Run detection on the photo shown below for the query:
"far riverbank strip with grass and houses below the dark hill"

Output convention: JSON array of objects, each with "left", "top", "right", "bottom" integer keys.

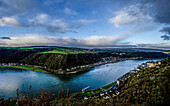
[{"left": 0, "top": 57, "right": 129, "bottom": 75}]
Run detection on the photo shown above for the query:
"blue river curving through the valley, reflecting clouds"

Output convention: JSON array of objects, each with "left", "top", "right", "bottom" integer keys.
[{"left": 0, "top": 59, "right": 162, "bottom": 98}]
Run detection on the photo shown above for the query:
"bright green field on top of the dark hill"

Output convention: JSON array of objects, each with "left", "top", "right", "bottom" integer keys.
[{"left": 40, "top": 49, "right": 85, "bottom": 54}]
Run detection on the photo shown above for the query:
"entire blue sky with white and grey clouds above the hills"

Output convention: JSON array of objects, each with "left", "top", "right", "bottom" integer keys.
[{"left": 0, "top": 0, "right": 170, "bottom": 49}]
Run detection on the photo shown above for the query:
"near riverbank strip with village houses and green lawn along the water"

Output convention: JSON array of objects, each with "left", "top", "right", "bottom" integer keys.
[{"left": 74, "top": 58, "right": 161, "bottom": 99}]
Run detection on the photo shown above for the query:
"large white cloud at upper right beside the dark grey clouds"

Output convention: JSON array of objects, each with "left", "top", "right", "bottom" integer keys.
[{"left": 108, "top": 4, "right": 162, "bottom": 44}]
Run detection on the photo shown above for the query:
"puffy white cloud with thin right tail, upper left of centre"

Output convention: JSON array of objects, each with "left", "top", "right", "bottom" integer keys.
[{"left": 29, "top": 14, "right": 96, "bottom": 33}]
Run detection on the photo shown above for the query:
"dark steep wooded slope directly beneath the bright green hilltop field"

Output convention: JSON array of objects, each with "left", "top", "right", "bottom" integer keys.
[{"left": 22, "top": 53, "right": 101, "bottom": 69}]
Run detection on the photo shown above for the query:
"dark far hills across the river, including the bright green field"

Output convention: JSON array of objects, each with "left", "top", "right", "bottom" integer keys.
[{"left": 0, "top": 47, "right": 168, "bottom": 69}]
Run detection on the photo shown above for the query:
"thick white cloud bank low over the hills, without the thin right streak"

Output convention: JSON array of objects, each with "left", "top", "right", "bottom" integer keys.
[{"left": 0, "top": 34, "right": 123, "bottom": 46}]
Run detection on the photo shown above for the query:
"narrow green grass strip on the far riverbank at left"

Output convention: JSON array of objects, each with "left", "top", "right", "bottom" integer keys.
[{"left": 0, "top": 66, "right": 49, "bottom": 73}]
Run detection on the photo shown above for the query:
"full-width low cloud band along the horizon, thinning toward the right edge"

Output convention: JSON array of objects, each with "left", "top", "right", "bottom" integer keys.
[{"left": 0, "top": 34, "right": 170, "bottom": 49}]
